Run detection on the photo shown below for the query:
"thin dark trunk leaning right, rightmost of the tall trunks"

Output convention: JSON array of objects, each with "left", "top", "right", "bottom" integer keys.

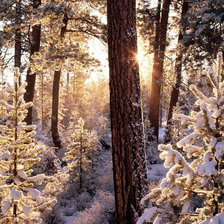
[{"left": 167, "top": 0, "right": 189, "bottom": 124}]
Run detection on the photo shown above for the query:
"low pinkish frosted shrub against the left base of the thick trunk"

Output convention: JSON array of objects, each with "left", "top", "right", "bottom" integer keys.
[{"left": 75, "top": 191, "right": 115, "bottom": 224}]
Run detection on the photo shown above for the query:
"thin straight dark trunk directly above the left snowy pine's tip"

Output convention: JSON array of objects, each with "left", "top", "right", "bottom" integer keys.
[{"left": 14, "top": 0, "right": 22, "bottom": 84}]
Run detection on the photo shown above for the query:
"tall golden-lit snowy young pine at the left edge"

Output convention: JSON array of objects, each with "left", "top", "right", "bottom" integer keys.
[{"left": 0, "top": 69, "right": 51, "bottom": 224}]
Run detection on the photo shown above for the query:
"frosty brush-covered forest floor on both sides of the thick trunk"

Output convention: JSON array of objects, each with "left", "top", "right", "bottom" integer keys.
[{"left": 36, "top": 125, "right": 167, "bottom": 224}]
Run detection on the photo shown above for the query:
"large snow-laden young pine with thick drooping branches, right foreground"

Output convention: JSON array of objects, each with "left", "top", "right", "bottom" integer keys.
[{"left": 138, "top": 53, "right": 224, "bottom": 224}]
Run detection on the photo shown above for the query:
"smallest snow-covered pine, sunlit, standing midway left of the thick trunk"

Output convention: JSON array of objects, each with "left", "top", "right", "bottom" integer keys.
[{"left": 65, "top": 118, "right": 98, "bottom": 191}]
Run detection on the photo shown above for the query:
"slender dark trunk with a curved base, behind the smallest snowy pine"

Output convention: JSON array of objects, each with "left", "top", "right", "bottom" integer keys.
[{"left": 51, "top": 14, "right": 68, "bottom": 148}]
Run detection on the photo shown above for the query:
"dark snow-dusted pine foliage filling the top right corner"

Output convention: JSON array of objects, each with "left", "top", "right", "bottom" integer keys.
[{"left": 184, "top": 0, "right": 224, "bottom": 64}]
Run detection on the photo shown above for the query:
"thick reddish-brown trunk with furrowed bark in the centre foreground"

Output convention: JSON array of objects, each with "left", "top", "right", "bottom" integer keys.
[{"left": 107, "top": 0, "right": 147, "bottom": 224}]
